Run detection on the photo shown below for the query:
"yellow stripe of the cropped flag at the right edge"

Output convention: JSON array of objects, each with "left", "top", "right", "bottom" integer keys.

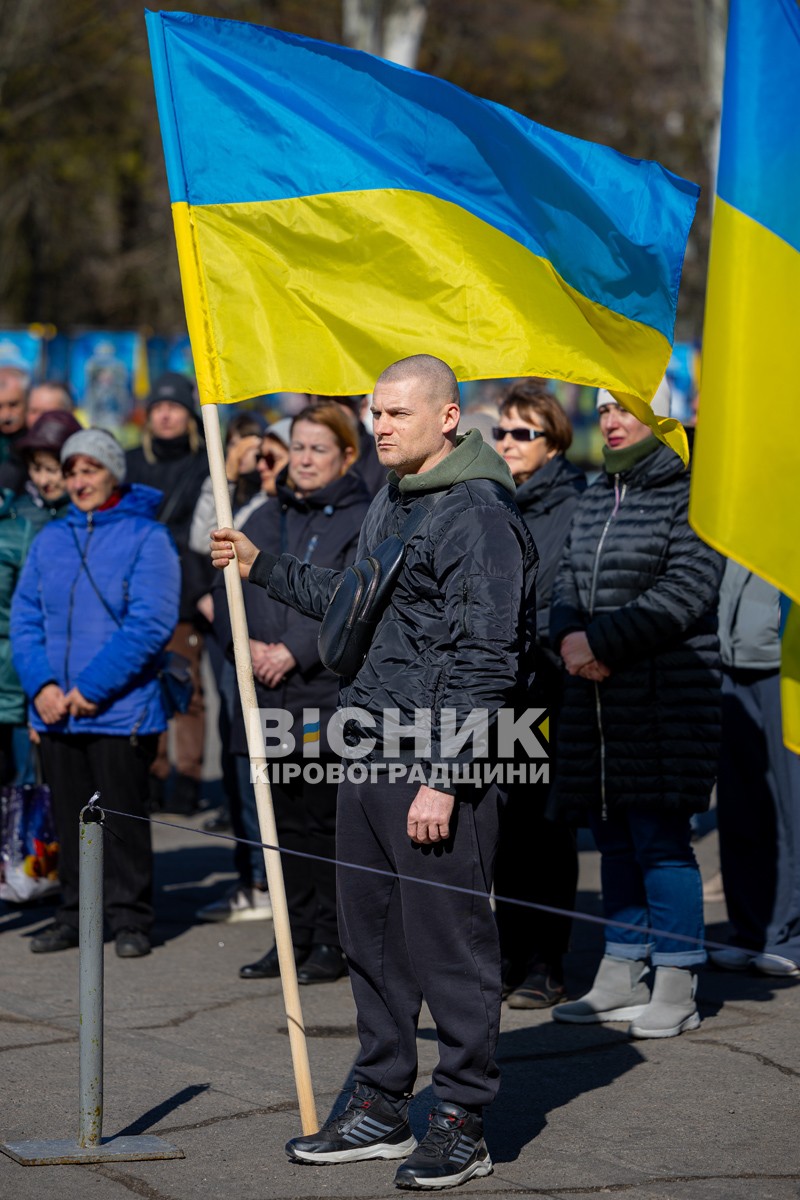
[{"left": 690, "top": 199, "right": 800, "bottom": 601}]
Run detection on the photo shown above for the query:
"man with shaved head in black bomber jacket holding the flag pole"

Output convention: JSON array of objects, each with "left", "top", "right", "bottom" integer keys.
[{"left": 211, "top": 354, "right": 536, "bottom": 1188}]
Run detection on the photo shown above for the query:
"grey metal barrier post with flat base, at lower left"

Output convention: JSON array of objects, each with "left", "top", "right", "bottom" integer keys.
[{"left": 0, "top": 792, "right": 185, "bottom": 1166}]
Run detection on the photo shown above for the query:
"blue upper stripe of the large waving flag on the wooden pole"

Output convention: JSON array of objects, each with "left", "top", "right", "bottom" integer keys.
[{"left": 149, "top": 13, "right": 697, "bottom": 340}]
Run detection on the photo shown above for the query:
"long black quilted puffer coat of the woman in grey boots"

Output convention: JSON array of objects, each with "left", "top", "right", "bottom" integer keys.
[{"left": 551, "top": 446, "right": 723, "bottom": 812}]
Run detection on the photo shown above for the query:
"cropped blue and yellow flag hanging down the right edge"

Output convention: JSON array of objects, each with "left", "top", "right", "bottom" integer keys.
[{"left": 690, "top": 0, "right": 800, "bottom": 750}]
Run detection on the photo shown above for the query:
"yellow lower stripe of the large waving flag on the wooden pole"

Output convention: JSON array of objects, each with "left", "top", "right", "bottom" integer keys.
[{"left": 173, "top": 190, "right": 670, "bottom": 403}]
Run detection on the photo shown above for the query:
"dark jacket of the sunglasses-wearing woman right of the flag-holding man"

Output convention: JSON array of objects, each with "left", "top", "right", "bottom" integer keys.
[{"left": 517, "top": 454, "right": 587, "bottom": 703}]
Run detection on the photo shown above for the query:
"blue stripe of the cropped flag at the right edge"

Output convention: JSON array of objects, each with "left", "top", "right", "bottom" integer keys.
[{"left": 717, "top": 0, "right": 800, "bottom": 251}]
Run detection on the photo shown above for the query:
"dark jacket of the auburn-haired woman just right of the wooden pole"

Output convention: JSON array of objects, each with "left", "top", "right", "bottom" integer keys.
[{"left": 219, "top": 468, "right": 369, "bottom": 755}]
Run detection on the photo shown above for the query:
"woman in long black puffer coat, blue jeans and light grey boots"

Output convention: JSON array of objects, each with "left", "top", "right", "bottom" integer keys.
[{"left": 551, "top": 382, "right": 723, "bottom": 1038}]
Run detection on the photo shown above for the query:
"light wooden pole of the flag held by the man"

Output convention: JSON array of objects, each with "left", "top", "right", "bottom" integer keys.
[{"left": 201, "top": 404, "right": 319, "bottom": 1134}]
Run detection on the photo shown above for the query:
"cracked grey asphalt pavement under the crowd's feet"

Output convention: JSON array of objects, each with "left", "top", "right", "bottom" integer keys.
[{"left": 0, "top": 796, "right": 800, "bottom": 1200}]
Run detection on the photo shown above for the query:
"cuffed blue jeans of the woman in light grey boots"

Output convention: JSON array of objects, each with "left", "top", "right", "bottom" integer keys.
[{"left": 589, "top": 808, "right": 706, "bottom": 967}]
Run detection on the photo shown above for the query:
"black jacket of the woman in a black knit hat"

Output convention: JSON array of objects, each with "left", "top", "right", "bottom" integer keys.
[{"left": 125, "top": 437, "right": 213, "bottom": 622}]
